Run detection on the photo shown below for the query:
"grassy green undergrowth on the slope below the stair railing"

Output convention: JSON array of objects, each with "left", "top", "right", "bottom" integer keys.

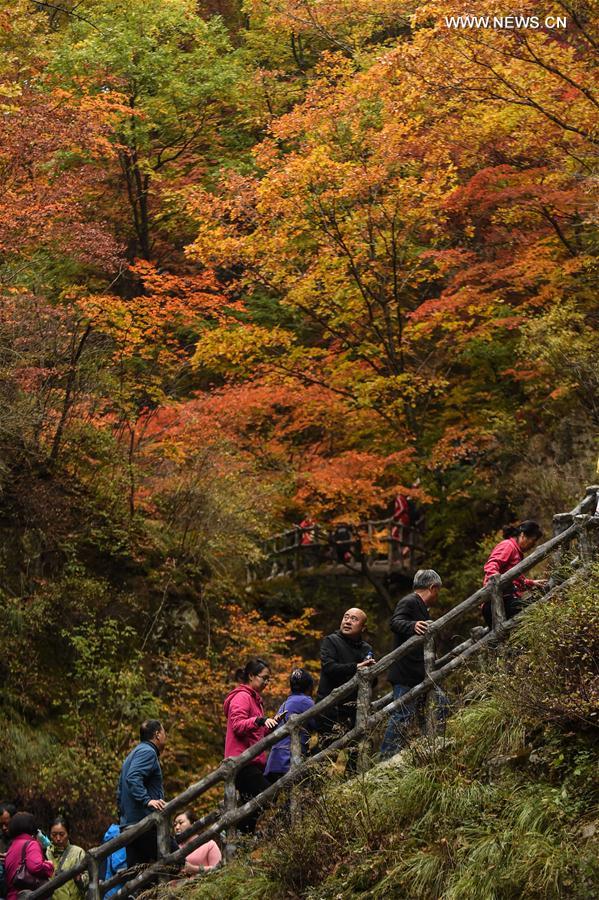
[{"left": 170, "top": 571, "right": 599, "bottom": 900}]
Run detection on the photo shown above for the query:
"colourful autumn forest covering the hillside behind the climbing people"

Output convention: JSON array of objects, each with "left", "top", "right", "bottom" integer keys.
[{"left": 0, "top": 0, "right": 599, "bottom": 843}]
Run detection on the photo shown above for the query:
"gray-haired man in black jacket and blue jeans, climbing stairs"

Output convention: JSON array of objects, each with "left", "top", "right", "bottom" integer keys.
[{"left": 381, "top": 569, "right": 447, "bottom": 756}]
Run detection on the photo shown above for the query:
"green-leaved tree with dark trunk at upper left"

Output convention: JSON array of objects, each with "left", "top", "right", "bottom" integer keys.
[{"left": 50, "top": 0, "right": 240, "bottom": 260}]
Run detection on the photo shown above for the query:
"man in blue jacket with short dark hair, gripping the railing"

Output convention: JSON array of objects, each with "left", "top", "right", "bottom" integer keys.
[{"left": 117, "top": 719, "right": 166, "bottom": 868}]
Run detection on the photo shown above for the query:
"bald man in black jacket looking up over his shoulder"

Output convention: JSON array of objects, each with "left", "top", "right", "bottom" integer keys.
[{"left": 316, "top": 607, "right": 374, "bottom": 735}]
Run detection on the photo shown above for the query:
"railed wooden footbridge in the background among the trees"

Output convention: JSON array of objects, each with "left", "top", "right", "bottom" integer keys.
[{"left": 247, "top": 518, "right": 424, "bottom": 583}]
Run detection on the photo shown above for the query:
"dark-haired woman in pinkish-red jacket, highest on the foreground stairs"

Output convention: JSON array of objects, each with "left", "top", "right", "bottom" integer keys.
[{"left": 482, "top": 519, "right": 546, "bottom": 628}]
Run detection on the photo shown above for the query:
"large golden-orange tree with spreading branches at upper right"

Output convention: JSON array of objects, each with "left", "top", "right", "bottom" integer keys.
[{"left": 189, "top": 3, "right": 595, "bottom": 506}]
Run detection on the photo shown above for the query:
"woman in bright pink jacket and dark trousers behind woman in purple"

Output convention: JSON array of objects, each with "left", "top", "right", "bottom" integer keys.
[{"left": 224, "top": 659, "right": 279, "bottom": 833}]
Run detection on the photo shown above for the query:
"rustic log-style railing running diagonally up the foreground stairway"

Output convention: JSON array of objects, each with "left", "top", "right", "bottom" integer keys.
[{"left": 28, "top": 485, "right": 599, "bottom": 900}]
